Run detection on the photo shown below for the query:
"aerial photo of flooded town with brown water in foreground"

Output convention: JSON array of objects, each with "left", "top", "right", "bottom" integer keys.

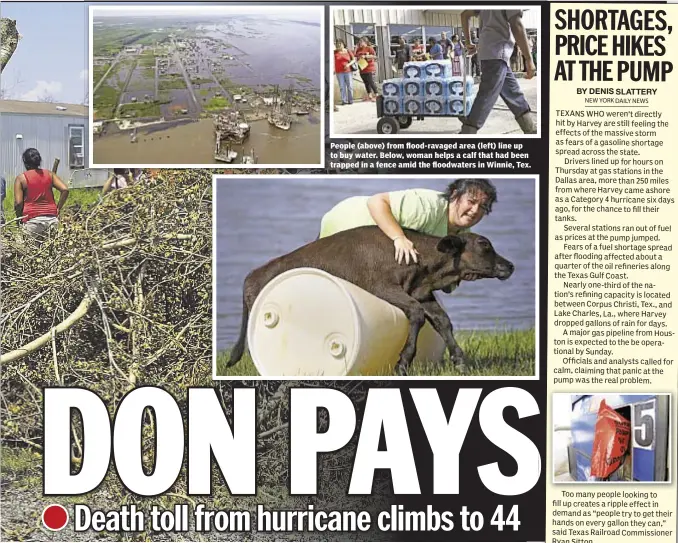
[{"left": 90, "top": 6, "right": 323, "bottom": 166}]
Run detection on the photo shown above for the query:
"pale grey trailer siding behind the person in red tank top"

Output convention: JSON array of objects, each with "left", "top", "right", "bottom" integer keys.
[{"left": 0, "top": 113, "right": 108, "bottom": 187}]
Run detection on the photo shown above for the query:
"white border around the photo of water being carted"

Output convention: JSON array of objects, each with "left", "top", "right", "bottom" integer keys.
[{"left": 327, "top": 4, "right": 548, "bottom": 139}]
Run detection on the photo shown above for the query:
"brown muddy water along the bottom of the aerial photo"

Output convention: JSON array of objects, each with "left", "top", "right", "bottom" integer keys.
[{"left": 94, "top": 116, "right": 320, "bottom": 166}]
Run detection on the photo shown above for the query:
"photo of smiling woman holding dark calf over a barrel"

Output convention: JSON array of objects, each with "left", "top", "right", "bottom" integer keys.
[{"left": 212, "top": 176, "right": 539, "bottom": 379}]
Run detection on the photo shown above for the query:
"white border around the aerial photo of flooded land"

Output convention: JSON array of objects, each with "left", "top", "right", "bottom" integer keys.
[{"left": 87, "top": 2, "right": 326, "bottom": 170}]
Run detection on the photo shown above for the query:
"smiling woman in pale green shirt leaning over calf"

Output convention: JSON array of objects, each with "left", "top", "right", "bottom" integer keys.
[{"left": 319, "top": 179, "right": 497, "bottom": 264}]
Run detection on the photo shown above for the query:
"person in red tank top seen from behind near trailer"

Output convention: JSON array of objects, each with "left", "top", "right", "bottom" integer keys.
[{"left": 14, "top": 148, "right": 68, "bottom": 241}]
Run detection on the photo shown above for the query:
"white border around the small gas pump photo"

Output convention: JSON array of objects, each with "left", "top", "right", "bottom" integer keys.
[{"left": 546, "top": 390, "right": 675, "bottom": 490}]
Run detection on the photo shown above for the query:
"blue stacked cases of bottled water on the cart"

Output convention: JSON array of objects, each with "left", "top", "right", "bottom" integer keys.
[{"left": 382, "top": 60, "right": 475, "bottom": 116}]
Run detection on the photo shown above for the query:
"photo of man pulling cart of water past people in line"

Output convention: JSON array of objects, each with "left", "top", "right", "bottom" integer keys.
[{"left": 330, "top": 6, "right": 541, "bottom": 137}]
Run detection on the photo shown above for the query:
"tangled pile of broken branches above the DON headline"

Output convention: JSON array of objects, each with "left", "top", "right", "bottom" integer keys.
[{"left": 0, "top": 170, "right": 212, "bottom": 450}]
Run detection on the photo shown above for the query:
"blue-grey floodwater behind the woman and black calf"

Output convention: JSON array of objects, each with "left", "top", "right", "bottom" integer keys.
[{"left": 214, "top": 176, "right": 535, "bottom": 350}]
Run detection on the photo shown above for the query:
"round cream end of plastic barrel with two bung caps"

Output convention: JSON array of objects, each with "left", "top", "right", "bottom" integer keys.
[{"left": 247, "top": 268, "right": 361, "bottom": 377}]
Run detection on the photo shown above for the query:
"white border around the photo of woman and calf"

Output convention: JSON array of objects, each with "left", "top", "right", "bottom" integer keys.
[{"left": 212, "top": 173, "right": 545, "bottom": 381}]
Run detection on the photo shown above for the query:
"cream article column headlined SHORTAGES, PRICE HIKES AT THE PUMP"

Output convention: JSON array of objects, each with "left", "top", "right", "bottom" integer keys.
[{"left": 546, "top": 4, "right": 678, "bottom": 542}]
